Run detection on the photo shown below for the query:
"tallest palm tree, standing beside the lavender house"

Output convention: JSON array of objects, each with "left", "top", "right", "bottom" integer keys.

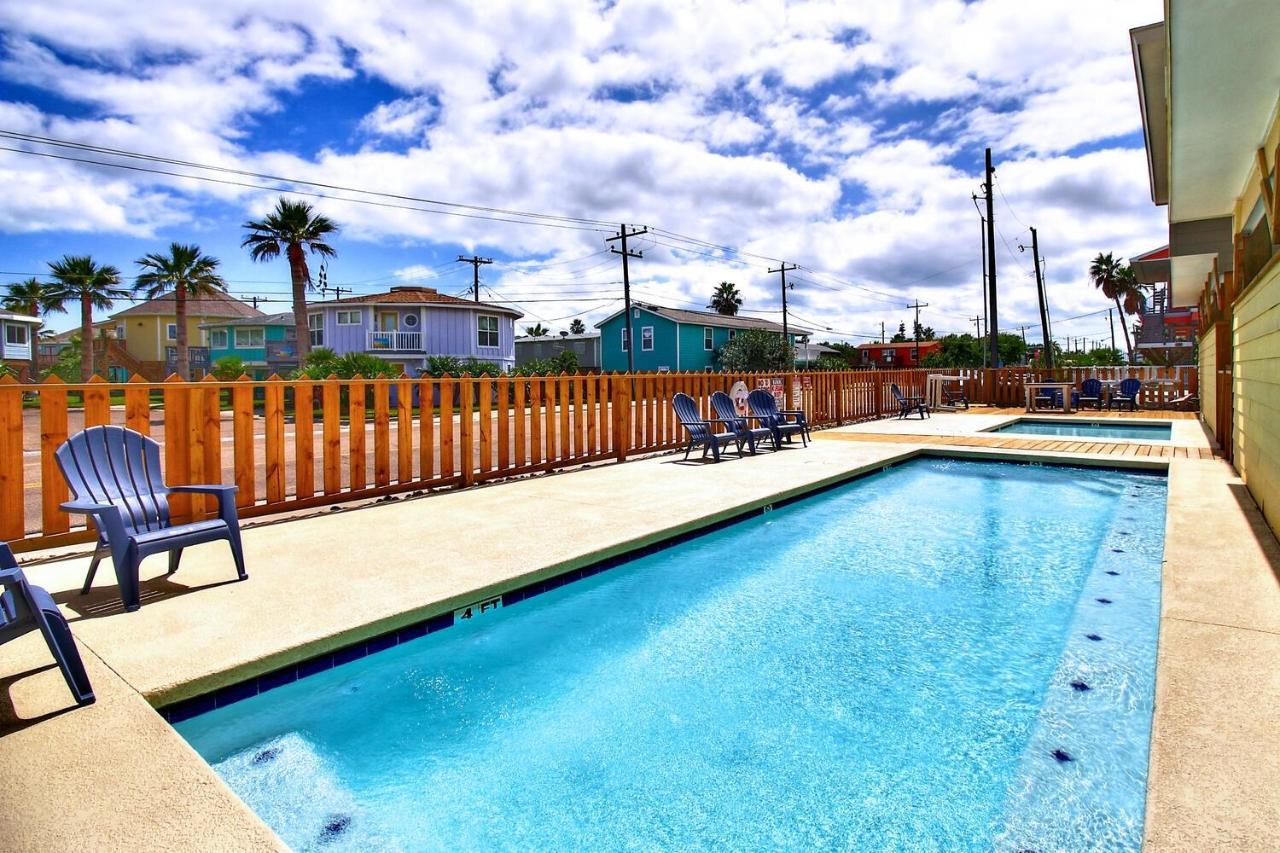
[{"left": 241, "top": 199, "right": 338, "bottom": 364}]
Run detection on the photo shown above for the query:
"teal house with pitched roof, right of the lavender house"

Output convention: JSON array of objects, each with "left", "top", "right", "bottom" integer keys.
[{"left": 595, "top": 302, "right": 809, "bottom": 373}]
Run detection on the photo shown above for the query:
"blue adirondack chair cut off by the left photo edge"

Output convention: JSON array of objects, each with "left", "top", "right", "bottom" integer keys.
[{"left": 0, "top": 542, "right": 93, "bottom": 704}]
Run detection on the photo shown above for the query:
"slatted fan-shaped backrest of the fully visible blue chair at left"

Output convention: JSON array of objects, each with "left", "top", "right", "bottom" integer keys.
[{"left": 54, "top": 425, "right": 169, "bottom": 532}]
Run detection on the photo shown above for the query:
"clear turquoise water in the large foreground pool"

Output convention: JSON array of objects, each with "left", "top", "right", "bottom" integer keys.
[{"left": 177, "top": 459, "right": 1166, "bottom": 852}]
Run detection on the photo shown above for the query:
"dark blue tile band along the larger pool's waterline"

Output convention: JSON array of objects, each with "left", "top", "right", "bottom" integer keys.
[{"left": 157, "top": 451, "right": 1158, "bottom": 724}]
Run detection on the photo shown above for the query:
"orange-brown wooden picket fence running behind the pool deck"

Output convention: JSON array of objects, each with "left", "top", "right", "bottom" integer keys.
[{"left": 0, "top": 368, "right": 1196, "bottom": 551}]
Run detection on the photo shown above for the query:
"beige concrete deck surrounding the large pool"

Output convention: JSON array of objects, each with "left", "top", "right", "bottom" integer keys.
[{"left": 0, "top": 415, "right": 1280, "bottom": 850}]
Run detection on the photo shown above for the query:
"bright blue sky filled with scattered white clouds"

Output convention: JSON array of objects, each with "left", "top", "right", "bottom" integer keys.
[{"left": 0, "top": 0, "right": 1167, "bottom": 343}]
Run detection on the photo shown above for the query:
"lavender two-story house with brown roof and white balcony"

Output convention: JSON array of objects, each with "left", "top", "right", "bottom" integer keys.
[{"left": 307, "top": 287, "right": 524, "bottom": 377}]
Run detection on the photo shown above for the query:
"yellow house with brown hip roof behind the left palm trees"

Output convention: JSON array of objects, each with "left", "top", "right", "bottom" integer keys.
[{"left": 108, "top": 293, "right": 265, "bottom": 379}]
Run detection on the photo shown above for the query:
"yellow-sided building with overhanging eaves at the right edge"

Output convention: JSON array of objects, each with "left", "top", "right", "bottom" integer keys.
[{"left": 1130, "top": 0, "right": 1280, "bottom": 530}]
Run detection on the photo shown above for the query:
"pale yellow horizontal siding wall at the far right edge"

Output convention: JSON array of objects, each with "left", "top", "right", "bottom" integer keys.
[{"left": 1233, "top": 262, "right": 1280, "bottom": 530}]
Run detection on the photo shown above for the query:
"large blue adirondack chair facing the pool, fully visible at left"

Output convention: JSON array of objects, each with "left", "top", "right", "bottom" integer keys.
[{"left": 54, "top": 427, "right": 248, "bottom": 611}]
